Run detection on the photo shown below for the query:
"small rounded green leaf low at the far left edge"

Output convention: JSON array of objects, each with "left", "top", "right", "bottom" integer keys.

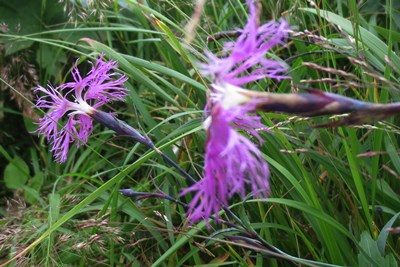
[{"left": 4, "top": 156, "right": 29, "bottom": 189}]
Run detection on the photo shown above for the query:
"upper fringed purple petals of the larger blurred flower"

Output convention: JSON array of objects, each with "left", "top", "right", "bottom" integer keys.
[{"left": 201, "top": 0, "right": 289, "bottom": 86}]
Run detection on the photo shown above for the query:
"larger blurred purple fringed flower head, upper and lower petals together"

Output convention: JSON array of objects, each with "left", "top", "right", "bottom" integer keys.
[{"left": 182, "top": 0, "right": 289, "bottom": 222}]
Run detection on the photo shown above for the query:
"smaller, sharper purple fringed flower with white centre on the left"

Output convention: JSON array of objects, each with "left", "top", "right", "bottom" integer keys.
[{"left": 36, "top": 55, "right": 127, "bottom": 163}]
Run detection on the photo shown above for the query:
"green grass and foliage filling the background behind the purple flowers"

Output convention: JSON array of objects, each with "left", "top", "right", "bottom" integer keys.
[{"left": 0, "top": 0, "right": 400, "bottom": 266}]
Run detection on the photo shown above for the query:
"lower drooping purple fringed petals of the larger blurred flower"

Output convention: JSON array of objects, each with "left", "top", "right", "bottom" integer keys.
[{"left": 182, "top": 94, "right": 269, "bottom": 222}]
